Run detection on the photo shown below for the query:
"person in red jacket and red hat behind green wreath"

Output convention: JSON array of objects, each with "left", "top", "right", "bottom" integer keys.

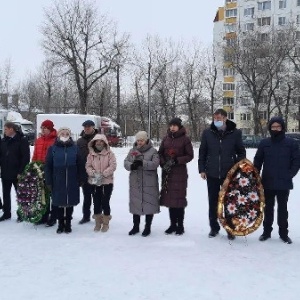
[{"left": 31, "top": 120, "right": 57, "bottom": 227}]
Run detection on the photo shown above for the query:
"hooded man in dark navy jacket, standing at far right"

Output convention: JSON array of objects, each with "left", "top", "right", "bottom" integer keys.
[{"left": 254, "top": 117, "right": 300, "bottom": 244}]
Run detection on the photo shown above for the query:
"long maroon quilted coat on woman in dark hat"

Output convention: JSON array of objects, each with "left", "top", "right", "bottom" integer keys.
[{"left": 158, "top": 127, "right": 194, "bottom": 208}]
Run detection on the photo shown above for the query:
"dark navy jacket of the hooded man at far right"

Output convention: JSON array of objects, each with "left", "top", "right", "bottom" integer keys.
[{"left": 254, "top": 136, "right": 300, "bottom": 190}]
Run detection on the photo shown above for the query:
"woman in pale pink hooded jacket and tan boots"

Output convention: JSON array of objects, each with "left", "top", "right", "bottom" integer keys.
[{"left": 85, "top": 134, "right": 117, "bottom": 232}]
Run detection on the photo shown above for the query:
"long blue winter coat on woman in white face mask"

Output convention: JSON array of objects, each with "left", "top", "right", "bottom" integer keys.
[{"left": 45, "top": 139, "right": 85, "bottom": 207}]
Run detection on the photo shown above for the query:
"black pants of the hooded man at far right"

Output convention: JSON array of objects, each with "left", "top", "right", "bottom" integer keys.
[{"left": 263, "top": 190, "right": 290, "bottom": 237}]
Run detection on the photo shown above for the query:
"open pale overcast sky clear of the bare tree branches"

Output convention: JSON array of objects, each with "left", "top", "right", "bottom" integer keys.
[{"left": 0, "top": 0, "right": 225, "bottom": 78}]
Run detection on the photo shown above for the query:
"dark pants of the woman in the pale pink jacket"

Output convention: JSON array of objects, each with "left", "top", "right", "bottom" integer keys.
[{"left": 93, "top": 183, "right": 113, "bottom": 216}]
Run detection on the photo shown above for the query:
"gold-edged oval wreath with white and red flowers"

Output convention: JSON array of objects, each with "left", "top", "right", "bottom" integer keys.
[{"left": 218, "top": 158, "right": 265, "bottom": 236}]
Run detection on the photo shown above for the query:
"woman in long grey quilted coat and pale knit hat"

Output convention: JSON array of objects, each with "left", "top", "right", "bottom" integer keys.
[{"left": 124, "top": 131, "right": 159, "bottom": 237}]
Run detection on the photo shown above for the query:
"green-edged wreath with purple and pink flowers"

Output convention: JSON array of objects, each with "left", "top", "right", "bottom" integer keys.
[{"left": 17, "top": 162, "right": 50, "bottom": 223}]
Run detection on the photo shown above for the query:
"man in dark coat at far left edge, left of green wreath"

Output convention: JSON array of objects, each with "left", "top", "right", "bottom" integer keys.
[{"left": 0, "top": 122, "right": 30, "bottom": 221}]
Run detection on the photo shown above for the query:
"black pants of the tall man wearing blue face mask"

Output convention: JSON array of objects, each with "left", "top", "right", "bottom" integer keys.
[{"left": 207, "top": 177, "right": 225, "bottom": 231}]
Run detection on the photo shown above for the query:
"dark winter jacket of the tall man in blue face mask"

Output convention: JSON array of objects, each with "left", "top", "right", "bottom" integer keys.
[{"left": 198, "top": 120, "right": 246, "bottom": 179}]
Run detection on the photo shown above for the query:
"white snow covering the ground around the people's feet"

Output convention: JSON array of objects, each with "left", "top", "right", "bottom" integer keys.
[{"left": 0, "top": 148, "right": 300, "bottom": 300}]
